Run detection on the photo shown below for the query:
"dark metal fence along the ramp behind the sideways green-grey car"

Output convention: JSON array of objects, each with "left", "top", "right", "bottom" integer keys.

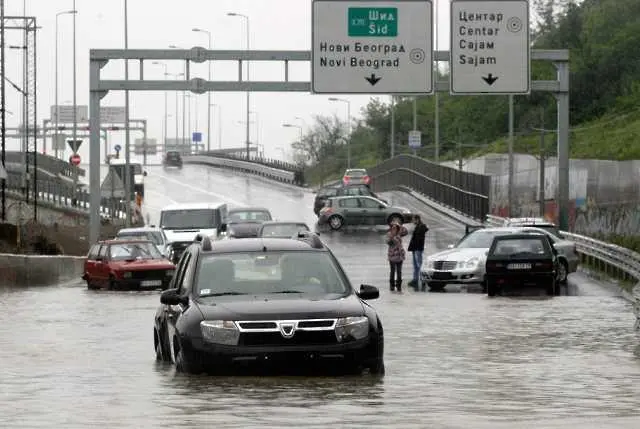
[{"left": 368, "top": 155, "right": 491, "bottom": 219}]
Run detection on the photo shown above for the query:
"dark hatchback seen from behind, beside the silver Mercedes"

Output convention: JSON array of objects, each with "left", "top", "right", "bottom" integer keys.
[{"left": 485, "top": 233, "right": 559, "bottom": 296}]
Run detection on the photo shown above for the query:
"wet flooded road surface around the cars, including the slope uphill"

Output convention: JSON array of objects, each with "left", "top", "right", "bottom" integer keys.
[{"left": 0, "top": 166, "right": 640, "bottom": 429}]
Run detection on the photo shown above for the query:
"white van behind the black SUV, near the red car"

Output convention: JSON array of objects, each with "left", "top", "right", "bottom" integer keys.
[{"left": 159, "top": 203, "right": 227, "bottom": 263}]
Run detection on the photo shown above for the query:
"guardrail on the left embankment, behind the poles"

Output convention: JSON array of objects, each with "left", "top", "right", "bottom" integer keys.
[{"left": 6, "top": 171, "right": 126, "bottom": 219}]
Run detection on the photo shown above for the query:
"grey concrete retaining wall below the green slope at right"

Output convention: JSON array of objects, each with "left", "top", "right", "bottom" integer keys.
[{"left": 443, "top": 154, "right": 640, "bottom": 235}]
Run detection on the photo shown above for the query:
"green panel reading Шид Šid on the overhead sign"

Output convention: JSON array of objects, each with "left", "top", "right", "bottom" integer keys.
[{"left": 349, "top": 7, "right": 398, "bottom": 37}]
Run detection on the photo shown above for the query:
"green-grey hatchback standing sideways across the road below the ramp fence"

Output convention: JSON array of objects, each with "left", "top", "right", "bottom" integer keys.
[{"left": 318, "top": 197, "right": 413, "bottom": 231}]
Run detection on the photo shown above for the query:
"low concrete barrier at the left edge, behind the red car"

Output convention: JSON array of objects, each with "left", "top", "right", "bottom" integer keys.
[{"left": 0, "top": 253, "right": 85, "bottom": 286}]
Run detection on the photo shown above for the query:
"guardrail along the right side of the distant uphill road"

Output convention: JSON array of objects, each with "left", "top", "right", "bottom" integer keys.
[{"left": 182, "top": 155, "right": 304, "bottom": 186}]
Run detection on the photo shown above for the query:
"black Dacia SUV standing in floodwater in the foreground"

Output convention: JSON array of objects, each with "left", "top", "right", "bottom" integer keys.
[{"left": 154, "top": 232, "right": 385, "bottom": 375}]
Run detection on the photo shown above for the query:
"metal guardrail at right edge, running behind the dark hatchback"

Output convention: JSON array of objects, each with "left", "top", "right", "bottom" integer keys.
[{"left": 486, "top": 215, "right": 640, "bottom": 282}]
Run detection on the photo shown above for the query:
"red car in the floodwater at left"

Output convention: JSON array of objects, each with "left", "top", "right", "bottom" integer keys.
[{"left": 82, "top": 240, "right": 176, "bottom": 290}]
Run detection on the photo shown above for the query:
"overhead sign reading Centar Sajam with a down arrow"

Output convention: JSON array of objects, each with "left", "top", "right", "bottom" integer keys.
[{"left": 450, "top": 0, "right": 531, "bottom": 95}]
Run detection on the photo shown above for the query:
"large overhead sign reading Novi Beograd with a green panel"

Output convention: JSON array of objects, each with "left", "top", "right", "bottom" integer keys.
[{"left": 311, "top": 0, "right": 433, "bottom": 95}]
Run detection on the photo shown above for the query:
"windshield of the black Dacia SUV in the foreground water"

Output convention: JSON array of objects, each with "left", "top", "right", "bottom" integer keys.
[{"left": 194, "top": 251, "right": 350, "bottom": 297}]
